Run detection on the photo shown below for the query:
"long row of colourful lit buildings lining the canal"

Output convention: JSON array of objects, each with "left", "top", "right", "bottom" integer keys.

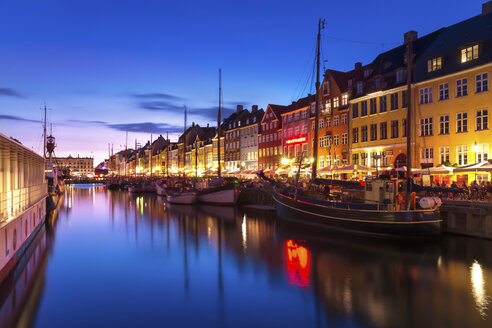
[{"left": 108, "top": 1, "right": 492, "bottom": 181}]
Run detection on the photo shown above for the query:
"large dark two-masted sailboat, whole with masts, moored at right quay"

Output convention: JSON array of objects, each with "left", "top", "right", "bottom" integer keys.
[{"left": 260, "top": 19, "right": 442, "bottom": 236}]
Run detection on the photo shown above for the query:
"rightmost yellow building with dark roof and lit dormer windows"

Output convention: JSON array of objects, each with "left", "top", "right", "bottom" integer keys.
[{"left": 415, "top": 6, "right": 492, "bottom": 183}]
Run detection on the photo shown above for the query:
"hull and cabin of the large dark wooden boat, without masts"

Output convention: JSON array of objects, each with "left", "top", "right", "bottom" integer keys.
[{"left": 273, "top": 179, "right": 442, "bottom": 236}]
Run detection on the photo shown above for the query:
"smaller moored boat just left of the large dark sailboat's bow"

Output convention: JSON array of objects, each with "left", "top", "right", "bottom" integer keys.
[{"left": 198, "top": 178, "right": 240, "bottom": 205}]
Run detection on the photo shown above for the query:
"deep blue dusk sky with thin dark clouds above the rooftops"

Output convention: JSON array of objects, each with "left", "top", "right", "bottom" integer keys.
[{"left": 0, "top": 0, "right": 484, "bottom": 161}]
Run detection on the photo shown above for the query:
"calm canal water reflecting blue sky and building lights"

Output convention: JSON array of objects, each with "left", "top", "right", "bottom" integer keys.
[{"left": 0, "top": 185, "right": 492, "bottom": 328}]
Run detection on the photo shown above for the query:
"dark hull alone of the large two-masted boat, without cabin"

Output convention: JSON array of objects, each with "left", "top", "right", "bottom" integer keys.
[{"left": 273, "top": 191, "right": 442, "bottom": 236}]
